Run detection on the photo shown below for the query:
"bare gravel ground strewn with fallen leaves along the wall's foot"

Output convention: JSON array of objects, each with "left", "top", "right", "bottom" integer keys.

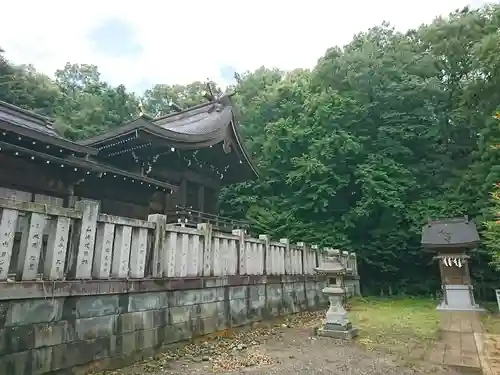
[{"left": 101, "top": 313, "right": 458, "bottom": 375}]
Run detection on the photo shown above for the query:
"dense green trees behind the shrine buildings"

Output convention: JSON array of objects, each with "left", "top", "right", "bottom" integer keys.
[{"left": 0, "top": 6, "right": 500, "bottom": 296}]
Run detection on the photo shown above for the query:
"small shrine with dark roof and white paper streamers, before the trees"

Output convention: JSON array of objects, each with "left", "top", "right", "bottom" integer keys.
[{"left": 421, "top": 216, "right": 482, "bottom": 311}]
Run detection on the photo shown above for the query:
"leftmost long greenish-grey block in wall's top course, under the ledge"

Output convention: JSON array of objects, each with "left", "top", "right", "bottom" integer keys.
[{"left": 5, "top": 299, "right": 63, "bottom": 326}]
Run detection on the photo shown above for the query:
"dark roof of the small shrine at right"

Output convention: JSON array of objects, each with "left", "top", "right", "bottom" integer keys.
[{"left": 421, "top": 217, "right": 480, "bottom": 248}]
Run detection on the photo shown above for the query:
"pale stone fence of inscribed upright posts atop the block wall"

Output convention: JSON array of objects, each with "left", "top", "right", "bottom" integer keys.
[{"left": 0, "top": 199, "right": 357, "bottom": 281}]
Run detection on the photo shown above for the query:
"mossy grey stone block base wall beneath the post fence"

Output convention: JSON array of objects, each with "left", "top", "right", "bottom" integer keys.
[{"left": 0, "top": 276, "right": 327, "bottom": 375}]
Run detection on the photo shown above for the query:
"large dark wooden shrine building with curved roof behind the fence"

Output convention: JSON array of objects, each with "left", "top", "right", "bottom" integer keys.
[{"left": 0, "top": 96, "right": 257, "bottom": 232}]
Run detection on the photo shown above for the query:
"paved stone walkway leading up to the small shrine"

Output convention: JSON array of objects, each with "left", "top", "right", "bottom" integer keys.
[{"left": 429, "top": 312, "right": 500, "bottom": 375}]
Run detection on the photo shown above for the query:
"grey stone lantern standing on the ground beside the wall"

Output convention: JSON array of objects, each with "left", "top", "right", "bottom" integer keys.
[{"left": 315, "top": 249, "right": 358, "bottom": 339}]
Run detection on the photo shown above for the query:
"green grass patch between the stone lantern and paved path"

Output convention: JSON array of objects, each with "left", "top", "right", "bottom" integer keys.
[{"left": 349, "top": 298, "right": 439, "bottom": 361}]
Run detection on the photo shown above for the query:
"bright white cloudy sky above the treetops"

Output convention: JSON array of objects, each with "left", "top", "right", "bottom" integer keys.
[{"left": 0, "top": 0, "right": 491, "bottom": 92}]
